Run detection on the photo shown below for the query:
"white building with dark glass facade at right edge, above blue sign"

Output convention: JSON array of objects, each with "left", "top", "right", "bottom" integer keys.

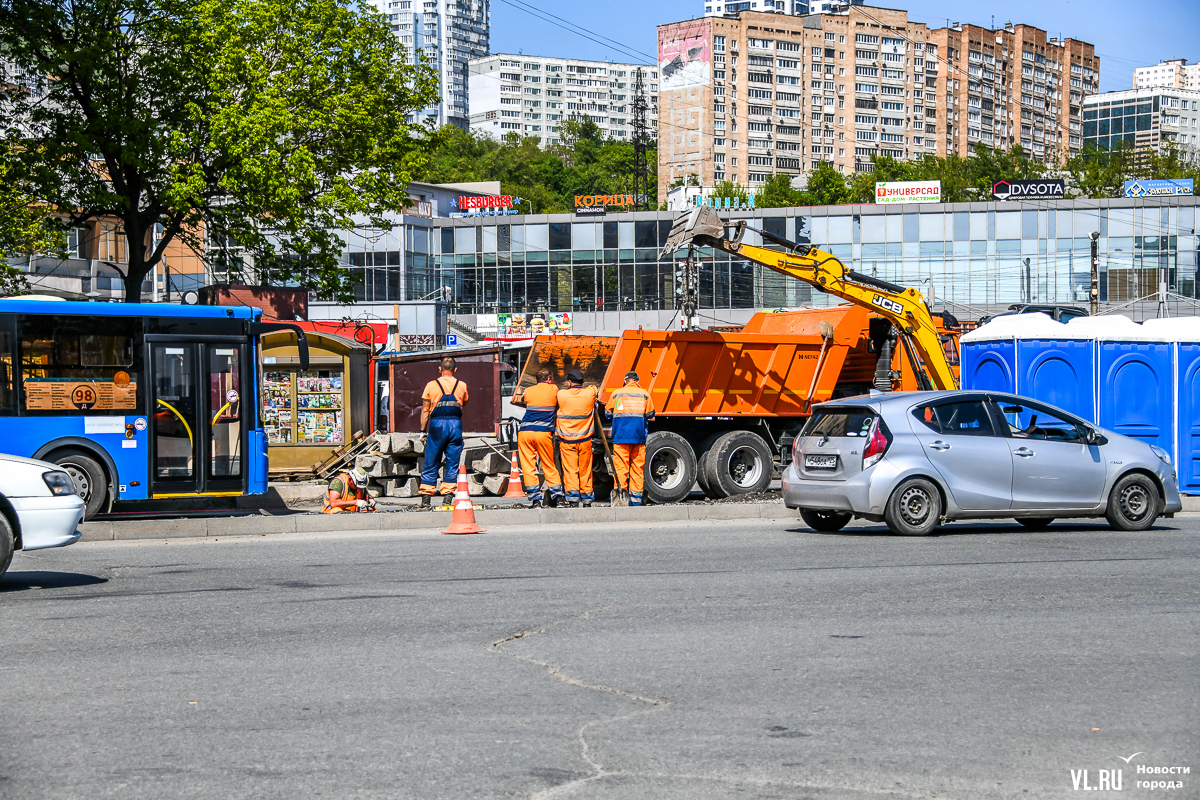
[{"left": 1084, "top": 88, "right": 1200, "bottom": 152}]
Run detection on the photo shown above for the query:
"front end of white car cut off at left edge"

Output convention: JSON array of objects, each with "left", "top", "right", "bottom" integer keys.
[{"left": 0, "top": 455, "right": 84, "bottom": 576}]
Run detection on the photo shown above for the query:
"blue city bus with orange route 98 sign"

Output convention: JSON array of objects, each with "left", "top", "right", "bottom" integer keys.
[{"left": 0, "top": 297, "right": 308, "bottom": 517}]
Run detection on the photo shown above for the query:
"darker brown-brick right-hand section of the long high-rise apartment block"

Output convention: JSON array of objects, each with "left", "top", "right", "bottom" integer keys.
[{"left": 930, "top": 23, "right": 1100, "bottom": 163}]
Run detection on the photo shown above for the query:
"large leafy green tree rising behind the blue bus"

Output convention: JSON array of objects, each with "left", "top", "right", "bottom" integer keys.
[{"left": 0, "top": 0, "right": 437, "bottom": 302}]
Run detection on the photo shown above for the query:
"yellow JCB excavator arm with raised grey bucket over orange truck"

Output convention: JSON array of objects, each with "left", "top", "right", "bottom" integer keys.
[{"left": 660, "top": 205, "right": 959, "bottom": 389}]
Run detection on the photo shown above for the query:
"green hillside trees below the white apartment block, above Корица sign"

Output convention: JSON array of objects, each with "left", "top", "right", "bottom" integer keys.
[{"left": 410, "top": 119, "right": 658, "bottom": 213}]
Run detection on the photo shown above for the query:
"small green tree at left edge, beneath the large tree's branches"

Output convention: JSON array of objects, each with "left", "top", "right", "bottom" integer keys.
[{"left": 0, "top": 142, "right": 66, "bottom": 296}]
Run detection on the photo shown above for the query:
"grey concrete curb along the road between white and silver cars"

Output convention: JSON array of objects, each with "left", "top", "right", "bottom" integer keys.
[{"left": 79, "top": 503, "right": 796, "bottom": 542}]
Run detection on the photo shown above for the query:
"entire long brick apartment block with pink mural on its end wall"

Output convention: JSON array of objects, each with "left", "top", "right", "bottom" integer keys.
[{"left": 658, "top": 6, "right": 1099, "bottom": 197}]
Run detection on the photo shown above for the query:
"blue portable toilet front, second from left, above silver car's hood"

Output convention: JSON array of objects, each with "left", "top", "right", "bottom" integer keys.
[{"left": 1016, "top": 338, "right": 1096, "bottom": 422}]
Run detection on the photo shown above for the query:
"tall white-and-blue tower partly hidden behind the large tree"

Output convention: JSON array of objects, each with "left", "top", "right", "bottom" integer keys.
[{"left": 370, "top": 0, "right": 491, "bottom": 130}]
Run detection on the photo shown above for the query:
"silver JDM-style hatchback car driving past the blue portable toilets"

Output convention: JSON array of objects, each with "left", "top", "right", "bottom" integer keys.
[{"left": 782, "top": 391, "right": 1183, "bottom": 536}]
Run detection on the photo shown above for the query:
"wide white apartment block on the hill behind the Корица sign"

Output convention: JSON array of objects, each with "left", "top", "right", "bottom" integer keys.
[{"left": 468, "top": 54, "right": 659, "bottom": 146}]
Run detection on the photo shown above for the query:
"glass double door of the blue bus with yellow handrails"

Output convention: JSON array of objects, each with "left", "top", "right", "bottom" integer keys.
[{"left": 148, "top": 337, "right": 246, "bottom": 497}]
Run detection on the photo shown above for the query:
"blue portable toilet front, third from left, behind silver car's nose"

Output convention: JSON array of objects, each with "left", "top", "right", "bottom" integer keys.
[{"left": 1099, "top": 341, "right": 1175, "bottom": 452}]
